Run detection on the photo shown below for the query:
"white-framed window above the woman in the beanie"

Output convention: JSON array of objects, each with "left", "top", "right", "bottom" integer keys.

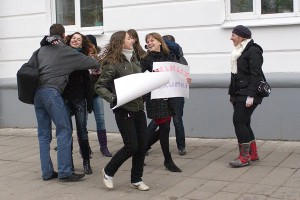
[{"left": 225, "top": 0, "right": 300, "bottom": 20}]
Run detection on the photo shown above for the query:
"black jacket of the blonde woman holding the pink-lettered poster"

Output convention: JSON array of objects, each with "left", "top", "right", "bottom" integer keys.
[{"left": 141, "top": 51, "right": 174, "bottom": 119}]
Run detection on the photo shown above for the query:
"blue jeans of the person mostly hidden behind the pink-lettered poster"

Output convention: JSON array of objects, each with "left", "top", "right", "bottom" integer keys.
[{"left": 148, "top": 97, "right": 185, "bottom": 149}]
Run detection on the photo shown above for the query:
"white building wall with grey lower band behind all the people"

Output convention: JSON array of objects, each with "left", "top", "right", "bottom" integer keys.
[{"left": 0, "top": 0, "right": 300, "bottom": 140}]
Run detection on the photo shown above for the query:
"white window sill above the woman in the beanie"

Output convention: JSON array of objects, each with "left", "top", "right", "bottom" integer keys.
[{"left": 221, "top": 17, "right": 300, "bottom": 29}]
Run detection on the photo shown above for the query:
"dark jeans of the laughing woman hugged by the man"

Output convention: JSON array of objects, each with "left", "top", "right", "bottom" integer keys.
[{"left": 67, "top": 99, "right": 89, "bottom": 141}]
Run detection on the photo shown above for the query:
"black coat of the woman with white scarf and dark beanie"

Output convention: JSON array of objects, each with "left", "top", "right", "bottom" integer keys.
[{"left": 228, "top": 40, "right": 263, "bottom": 104}]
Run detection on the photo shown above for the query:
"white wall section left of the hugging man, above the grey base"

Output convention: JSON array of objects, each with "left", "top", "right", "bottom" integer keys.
[{"left": 0, "top": 0, "right": 51, "bottom": 78}]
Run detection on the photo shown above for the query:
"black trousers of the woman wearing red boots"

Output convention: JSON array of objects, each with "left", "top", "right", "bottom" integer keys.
[{"left": 233, "top": 102, "right": 257, "bottom": 143}]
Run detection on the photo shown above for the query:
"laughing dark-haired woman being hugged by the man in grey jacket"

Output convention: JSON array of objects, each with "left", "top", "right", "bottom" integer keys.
[{"left": 62, "top": 32, "right": 93, "bottom": 174}]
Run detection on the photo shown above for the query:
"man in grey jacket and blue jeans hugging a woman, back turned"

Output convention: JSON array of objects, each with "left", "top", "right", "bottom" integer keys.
[{"left": 34, "top": 24, "right": 98, "bottom": 181}]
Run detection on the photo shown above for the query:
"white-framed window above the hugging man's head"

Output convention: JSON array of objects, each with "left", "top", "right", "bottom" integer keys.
[{"left": 52, "top": 0, "right": 103, "bottom": 34}]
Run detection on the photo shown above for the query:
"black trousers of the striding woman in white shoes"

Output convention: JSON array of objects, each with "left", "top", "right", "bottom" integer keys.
[{"left": 104, "top": 108, "right": 147, "bottom": 183}]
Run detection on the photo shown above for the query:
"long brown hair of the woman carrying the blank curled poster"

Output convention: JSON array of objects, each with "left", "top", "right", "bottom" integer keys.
[{"left": 101, "top": 31, "right": 126, "bottom": 65}]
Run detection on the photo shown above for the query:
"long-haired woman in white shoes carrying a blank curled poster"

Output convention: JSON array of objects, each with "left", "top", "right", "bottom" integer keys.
[{"left": 95, "top": 31, "right": 149, "bottom": 191}]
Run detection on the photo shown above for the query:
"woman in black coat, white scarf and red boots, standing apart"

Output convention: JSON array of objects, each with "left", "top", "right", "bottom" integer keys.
[{"left": 229, "top": 25, "right": 263, "bottom": 167}]
